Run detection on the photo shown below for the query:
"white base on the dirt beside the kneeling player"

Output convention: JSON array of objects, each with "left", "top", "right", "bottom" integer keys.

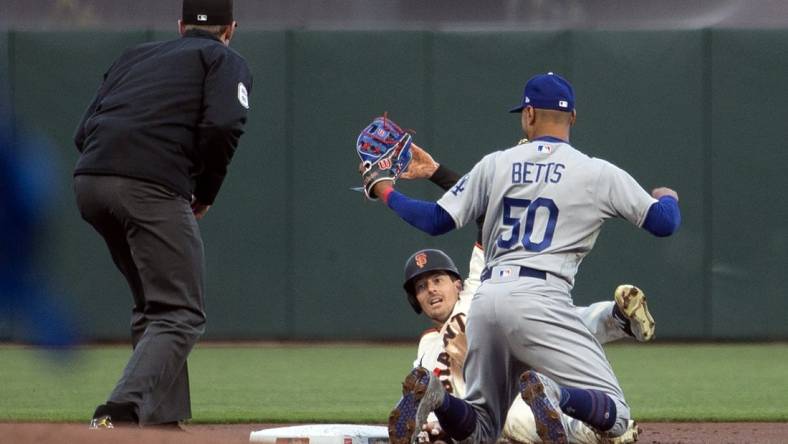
[{"left": 249, "top": 424, "right": 389, "bottom": 444}]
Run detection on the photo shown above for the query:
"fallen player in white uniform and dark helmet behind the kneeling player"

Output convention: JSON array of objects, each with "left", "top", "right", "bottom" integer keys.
[{"left": 400, "top": 248, "right": 655, "bottom": 444}]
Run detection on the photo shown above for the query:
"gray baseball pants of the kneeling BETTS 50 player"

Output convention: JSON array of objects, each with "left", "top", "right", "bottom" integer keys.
[{"left": 464, "top": 267, "right": 629, "bottom": 443}]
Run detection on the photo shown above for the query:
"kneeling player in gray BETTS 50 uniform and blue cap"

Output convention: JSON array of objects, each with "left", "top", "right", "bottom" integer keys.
[{"left": 372, "top": 73, "right": 681, "bottom": 443}]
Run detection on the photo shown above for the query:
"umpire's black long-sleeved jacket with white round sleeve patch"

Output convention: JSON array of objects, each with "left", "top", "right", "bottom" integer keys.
[{"left": 74, "top": 30, "right": 252, "bottom": 204}]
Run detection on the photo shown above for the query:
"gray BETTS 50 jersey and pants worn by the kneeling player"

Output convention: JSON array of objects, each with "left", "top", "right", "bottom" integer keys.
[{"left": 438, "top": 138, "right": 656, "bottom": 443}]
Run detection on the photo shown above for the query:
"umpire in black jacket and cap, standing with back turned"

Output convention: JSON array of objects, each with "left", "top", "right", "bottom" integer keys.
[{"left": 74, "top": 0, "right": 252, "bottom": 428}]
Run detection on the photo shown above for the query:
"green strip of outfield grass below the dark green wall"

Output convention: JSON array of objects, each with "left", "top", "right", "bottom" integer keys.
[{"left": 0, "top": 344, "right": 788, "bottom": 423}]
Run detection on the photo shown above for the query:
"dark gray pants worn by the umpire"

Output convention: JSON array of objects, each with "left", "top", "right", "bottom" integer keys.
[{"left": 74, "top": 175, "right": 205, "bottom": 425}]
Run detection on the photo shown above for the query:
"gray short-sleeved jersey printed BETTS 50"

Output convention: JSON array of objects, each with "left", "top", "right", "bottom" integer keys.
[{"left": 438, "top": 139, "right": 656, "bottom": 284}]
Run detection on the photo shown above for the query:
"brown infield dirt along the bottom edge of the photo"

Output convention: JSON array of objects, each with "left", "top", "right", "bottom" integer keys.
[{"left": 0, "top": 422, "right": 788, "bottom": 444}]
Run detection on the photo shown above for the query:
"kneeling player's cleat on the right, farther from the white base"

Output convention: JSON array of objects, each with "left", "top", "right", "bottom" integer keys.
[{"left": 520, "top": 370, "right": 569, "bottom": 444}]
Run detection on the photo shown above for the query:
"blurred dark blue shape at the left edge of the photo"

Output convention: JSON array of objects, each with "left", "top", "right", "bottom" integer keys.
[{"left": 0, "top": 100, "right": 78, "bottom": 348}]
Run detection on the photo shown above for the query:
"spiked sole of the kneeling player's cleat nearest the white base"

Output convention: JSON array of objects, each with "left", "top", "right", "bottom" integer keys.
[{"left": 389, "top": 367, "right": 430, "bottom": 444}]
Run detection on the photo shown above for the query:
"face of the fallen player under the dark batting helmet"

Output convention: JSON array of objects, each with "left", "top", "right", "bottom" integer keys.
[{"left": 413, "top": 271, "right": 462, "bottom": 324}]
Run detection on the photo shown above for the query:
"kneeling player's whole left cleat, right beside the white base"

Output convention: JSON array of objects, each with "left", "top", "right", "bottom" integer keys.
[{"left": 389, "top": 367, "right": 446, "bottom": 444}]
